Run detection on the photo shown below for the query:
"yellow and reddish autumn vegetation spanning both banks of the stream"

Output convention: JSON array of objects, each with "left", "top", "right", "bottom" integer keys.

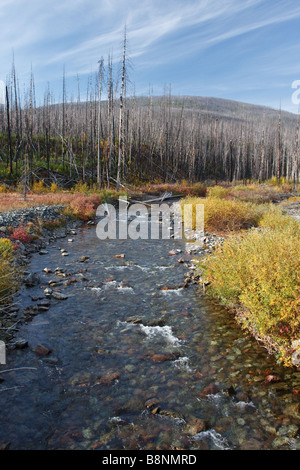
[{"left": 0, "top": 179, "right": 300, "bottom": 367}]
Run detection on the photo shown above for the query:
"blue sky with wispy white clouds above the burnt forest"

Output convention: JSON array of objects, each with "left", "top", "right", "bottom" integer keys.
[{"left": 0, "top": 0, "right": 300, "bottom": 113}]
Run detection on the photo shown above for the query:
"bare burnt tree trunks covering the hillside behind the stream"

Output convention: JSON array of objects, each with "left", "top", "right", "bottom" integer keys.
[{"left": 0, "top": 54, "right": 300, "bottom": 186}]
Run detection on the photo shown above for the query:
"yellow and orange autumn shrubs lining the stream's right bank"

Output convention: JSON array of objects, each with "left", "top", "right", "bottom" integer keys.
[{"left": 182, "top": 180, "right": 300, "bottom": 367}]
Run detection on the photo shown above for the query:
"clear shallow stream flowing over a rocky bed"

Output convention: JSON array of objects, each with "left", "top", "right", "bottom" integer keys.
[{"left": 0, "top": 210, "right": 300, "bottom": 450}]
